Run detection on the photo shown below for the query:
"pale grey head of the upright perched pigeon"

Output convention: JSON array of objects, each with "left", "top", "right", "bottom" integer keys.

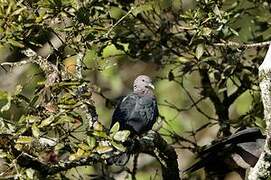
[{"left": 134, "top": 75, "right": 154, "bottom": 95}]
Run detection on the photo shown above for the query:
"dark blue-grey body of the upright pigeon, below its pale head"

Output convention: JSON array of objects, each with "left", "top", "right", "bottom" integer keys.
[{"left": 111, "top": 93, "right": 158, "bottom": 135}]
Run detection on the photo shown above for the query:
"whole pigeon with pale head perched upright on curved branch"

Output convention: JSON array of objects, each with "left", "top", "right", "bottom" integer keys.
[{"left": 110, "top": 75, "right": 158, "bottom": 135}]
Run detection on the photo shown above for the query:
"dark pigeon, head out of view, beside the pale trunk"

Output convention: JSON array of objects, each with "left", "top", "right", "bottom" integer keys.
[{"left": 184, "top": 128, "right": 265, "bottom": 179}]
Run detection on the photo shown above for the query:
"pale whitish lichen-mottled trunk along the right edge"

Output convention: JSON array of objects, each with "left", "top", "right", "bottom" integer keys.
[{"left": 248, "top": 44, "right": 271, "bottom": 180}]
